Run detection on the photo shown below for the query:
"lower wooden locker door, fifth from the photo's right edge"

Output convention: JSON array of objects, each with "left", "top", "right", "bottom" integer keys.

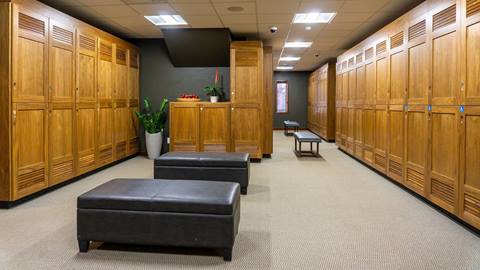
[{"left": 375, "top": 107, "right": 388, "bottom": 173}]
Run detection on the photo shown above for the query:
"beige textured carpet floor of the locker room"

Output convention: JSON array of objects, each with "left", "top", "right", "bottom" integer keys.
[{"left": 0, "top": 132, "right": 480, "bottom": 270}]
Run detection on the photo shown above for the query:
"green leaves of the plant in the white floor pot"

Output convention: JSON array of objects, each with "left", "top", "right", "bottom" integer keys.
[{"left": 135, "top": 98, "right": 168, "bottom": 134}]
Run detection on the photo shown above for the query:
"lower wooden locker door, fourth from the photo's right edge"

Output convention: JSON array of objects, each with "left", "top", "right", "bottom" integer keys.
[{"left": 387, "top": 105, "right": 405, "bottom": 182}]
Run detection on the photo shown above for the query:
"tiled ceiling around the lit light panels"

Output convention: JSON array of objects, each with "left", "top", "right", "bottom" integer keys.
[{"left": 41, "top": 0, "right": 422, "bottom": 71}]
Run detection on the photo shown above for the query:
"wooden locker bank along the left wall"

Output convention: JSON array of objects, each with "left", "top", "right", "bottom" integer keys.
[{"left": 0, "top": 0, "right": 139, "bottom": 205}]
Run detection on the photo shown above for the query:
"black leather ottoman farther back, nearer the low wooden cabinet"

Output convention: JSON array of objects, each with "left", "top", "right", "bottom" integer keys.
[{"left": 154, "top": 152, "right": 250, "bottom": 194}]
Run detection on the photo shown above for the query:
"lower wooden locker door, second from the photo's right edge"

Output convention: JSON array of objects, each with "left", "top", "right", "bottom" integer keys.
[{"left": 428, "top": 106, "right": 459, "bottom": 213}]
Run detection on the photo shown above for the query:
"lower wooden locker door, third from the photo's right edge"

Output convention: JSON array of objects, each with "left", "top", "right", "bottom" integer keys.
[{"left": 405, "top": 105, "right": 428, "bottom": 196}]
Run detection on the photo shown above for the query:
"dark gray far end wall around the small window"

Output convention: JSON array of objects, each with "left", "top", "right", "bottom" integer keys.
[{"left": 273, "top": 72, "right": 310, "bottom": 128}]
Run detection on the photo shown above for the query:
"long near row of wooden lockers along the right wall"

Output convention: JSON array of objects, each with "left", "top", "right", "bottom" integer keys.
[{"left": 337, "top": 0, "right": 480, "bottom": 228}]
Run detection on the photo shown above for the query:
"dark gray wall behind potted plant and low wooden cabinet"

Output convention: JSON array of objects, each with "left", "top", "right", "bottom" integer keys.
[{"left": 131, "top": 39, "right": 230, "bottom": 151}]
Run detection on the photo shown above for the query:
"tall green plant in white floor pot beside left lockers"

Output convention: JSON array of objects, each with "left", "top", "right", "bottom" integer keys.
[{"left": 135, "top": 98, "right": 168, "bottom": 159}]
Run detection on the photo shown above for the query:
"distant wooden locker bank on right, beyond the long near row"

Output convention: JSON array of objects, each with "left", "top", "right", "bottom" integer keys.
[{"left": 307, "top": 63, "right": 340, "bottom": 141}]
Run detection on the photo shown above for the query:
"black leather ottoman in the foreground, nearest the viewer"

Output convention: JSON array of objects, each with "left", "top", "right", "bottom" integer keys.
[{"left": 77, "top": 179, "right": 240, "bottom": 261}]
